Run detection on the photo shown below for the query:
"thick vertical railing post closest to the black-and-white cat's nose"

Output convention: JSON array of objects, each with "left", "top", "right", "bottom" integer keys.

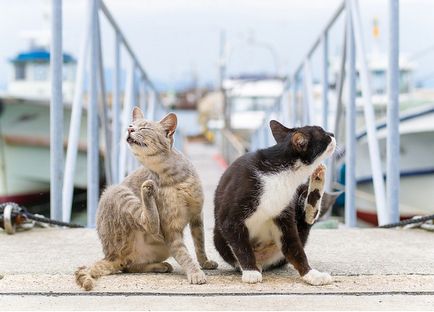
[{"left": 345, "top": 0, "right": 357, "bottom": 227}]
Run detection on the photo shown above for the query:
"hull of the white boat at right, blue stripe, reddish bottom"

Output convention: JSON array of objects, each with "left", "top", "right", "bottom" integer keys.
[{"left": 339, "top": 105, "right": 434, "bottom": 224}]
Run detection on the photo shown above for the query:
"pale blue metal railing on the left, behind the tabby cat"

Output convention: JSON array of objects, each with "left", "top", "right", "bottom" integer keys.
[{"left": 50, "top": 0, "right": 175, "bottom": 227}]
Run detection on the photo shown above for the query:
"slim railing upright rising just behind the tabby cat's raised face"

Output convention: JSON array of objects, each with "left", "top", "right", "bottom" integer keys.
[{"left": 111, "top": 30, "right": 121, "bottom": 183}]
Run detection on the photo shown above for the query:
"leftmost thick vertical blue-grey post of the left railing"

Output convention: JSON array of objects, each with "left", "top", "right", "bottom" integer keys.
[{"left": 50, "top": 0, "right": 63, "bottom": 220}]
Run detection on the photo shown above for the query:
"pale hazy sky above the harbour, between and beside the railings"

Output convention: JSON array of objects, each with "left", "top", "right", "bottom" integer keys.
[{"left": 0, "top": 0, "right": 434, "bottom": 88}]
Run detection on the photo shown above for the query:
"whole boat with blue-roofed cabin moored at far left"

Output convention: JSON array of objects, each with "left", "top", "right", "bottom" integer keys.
[{"left": 0, "top": 42, "right": 94, "bottom": 204}]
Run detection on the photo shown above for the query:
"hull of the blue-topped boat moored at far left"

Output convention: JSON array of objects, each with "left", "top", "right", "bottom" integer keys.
[{"left": 0, "top": 98, "right": 102, "bottom": 204}]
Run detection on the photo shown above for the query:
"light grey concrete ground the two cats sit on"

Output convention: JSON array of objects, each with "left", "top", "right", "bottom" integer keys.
[{"left": 0, "top": 145, "right": 434, "bottom": 310}]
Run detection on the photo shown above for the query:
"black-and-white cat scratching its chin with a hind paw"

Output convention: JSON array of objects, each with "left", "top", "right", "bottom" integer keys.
[{"left": 214, "top": 120, "right": 336, "bottom": 285}]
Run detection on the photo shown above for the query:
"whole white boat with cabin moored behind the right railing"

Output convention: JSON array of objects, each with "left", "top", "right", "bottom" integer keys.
[{"left": 314, "top": 20, "right": 434, "bottom": 224}]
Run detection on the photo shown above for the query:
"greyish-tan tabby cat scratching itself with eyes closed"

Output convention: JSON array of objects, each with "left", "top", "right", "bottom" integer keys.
[{"left": 75, "top": 107, "right": 217, "bottom": 290}]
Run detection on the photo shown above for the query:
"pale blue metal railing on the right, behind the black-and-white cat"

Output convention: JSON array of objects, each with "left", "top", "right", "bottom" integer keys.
[{"left": 251, "top": 0, "right": 400, "bottom": 227}]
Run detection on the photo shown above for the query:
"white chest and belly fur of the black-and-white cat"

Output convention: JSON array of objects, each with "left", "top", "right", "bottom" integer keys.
[{"left": 245, "top": 166, "right": 312, "bottom": 241}]
